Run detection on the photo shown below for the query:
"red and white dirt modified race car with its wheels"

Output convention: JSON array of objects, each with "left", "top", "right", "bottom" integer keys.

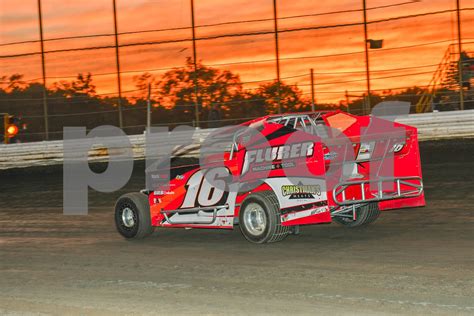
[{"left": 115, "top": 111, "right": 425, "bottom": 243}]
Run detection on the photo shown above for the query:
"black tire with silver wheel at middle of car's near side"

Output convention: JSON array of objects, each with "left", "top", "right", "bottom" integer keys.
[{"left": 239, "top": 191, "right": 291, "bottom": 244}]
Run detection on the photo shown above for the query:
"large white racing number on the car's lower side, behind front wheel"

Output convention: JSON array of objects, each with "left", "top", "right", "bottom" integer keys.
[{"left": 181, "top": 168, "right": 230, "bottom": 208}]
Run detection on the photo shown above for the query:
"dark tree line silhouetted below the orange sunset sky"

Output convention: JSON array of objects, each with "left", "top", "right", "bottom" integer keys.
[{"left": 0, "top": 58, "right": 446, "bottom": 141}]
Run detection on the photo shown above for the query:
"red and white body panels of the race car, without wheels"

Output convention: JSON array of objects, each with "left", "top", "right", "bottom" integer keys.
[{"left": 149, "top": 111, "right": 425, "bottom": 229}]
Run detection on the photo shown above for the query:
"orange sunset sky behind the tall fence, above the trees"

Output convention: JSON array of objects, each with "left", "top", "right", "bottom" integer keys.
[{"left": 0, "top": 0, "right": 474, "bottom": 102}]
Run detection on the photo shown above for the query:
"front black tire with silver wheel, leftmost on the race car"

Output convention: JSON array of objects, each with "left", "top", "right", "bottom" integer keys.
[{"left": 115, "top": 192, "right": 153, "bottom": 239}]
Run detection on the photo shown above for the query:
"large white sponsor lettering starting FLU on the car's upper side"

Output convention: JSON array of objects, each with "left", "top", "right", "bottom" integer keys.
[{"left": 242, "top": 142, "right": 314, "bottom": 174}]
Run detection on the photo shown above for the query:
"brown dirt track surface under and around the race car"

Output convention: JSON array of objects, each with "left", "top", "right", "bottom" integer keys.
[{"left": 0, "top": 139, "right": 474, "bottom": 315}]
